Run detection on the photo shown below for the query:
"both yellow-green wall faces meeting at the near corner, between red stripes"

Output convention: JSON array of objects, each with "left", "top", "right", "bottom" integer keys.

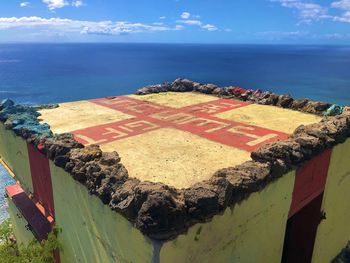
[{"left": 50, "top": 162, "right": 294, "bottom": 263}]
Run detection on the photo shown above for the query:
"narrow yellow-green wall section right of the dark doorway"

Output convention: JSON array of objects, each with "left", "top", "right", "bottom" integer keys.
[{"left": 312, "top": 139, "right": 350, "bottom": 263}]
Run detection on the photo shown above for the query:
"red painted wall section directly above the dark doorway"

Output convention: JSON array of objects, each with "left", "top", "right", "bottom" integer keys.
[{"left": 289, "top": 149, "right": 332, "bottom": 217}]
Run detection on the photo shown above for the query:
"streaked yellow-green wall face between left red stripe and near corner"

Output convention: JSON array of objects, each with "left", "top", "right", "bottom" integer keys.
[{"left": 50, "top": 164, "right": 153, "bottom": 263}]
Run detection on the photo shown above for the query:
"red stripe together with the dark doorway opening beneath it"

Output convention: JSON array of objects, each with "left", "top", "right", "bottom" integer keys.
[{"left": 282, "top": 150, "right": 332, "bottom": 263}]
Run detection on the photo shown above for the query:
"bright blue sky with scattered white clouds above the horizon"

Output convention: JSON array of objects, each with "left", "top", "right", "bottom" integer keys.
[{"left": 0, "top": 0, "right": 350, "bottom": 45}]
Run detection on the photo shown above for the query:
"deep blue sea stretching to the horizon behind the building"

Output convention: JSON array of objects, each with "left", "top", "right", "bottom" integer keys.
[{"left": 0, "top": 43, "right": 350, "bottom": 222}]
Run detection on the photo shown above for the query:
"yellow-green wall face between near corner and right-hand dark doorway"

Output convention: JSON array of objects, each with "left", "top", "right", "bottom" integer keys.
[{"left": 160, "top": 172, "right": 295, "bottom": 263}]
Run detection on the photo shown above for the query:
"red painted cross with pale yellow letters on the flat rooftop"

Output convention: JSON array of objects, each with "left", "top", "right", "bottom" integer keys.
[{"left": 73, "top": 97, "right": 288, "bottom": 151}]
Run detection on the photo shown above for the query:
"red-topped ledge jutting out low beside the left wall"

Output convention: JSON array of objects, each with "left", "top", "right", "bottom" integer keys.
[{"left": 5, "top": 184, "right": 51, "bottom": 241}]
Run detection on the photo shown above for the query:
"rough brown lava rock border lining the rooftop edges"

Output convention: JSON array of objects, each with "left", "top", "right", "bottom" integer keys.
[{"left": 0, "top": 80, "right": 350, "bottom": 240}]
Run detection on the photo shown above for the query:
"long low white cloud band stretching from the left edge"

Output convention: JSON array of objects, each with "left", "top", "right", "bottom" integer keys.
[{"left": 0, "top": 16, "right": 182, "bottom": 35}]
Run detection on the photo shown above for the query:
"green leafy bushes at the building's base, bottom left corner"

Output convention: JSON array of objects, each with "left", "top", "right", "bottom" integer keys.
[{"left": 0, "top": 219, "right": 60, "bottom": 263}]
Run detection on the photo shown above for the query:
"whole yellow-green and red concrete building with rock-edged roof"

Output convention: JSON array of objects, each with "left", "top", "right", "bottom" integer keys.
[{"left": 0, "top": 82, "right": 350, "bottom": 263}]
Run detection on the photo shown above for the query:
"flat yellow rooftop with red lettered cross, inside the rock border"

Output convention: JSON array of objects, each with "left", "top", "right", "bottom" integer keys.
[{"left": 40, "top": 92, "right": 321, "bottom": 188}]
